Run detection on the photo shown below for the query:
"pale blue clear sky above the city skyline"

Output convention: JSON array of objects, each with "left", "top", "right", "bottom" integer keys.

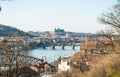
[{"left": 0, "top": 0, "right": 117, "bottom": 33}]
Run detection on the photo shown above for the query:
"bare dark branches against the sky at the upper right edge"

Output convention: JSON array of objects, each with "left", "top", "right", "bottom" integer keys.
[{"left": 98, "top": 0, "right": 120, "bottom": 33}]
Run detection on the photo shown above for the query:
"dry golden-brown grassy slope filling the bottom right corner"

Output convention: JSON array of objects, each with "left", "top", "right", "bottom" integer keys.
[{"left": 80, "top": 54, "right": 120, "bottom": 77}]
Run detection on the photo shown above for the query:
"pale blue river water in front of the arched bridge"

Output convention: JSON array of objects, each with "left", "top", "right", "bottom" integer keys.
[{"left": 29, "top": 46, "right": 80, "bottom": 63}]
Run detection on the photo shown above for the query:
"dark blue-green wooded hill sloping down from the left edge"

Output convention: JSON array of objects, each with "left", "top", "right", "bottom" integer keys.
[{"left": 0, "top": 24, "right": 32, "bottom": 37}]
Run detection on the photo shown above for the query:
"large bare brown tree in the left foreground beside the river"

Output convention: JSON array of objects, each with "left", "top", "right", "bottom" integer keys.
[{"left": 0, "top": 36, "right": 30, "bottom": 77}]
